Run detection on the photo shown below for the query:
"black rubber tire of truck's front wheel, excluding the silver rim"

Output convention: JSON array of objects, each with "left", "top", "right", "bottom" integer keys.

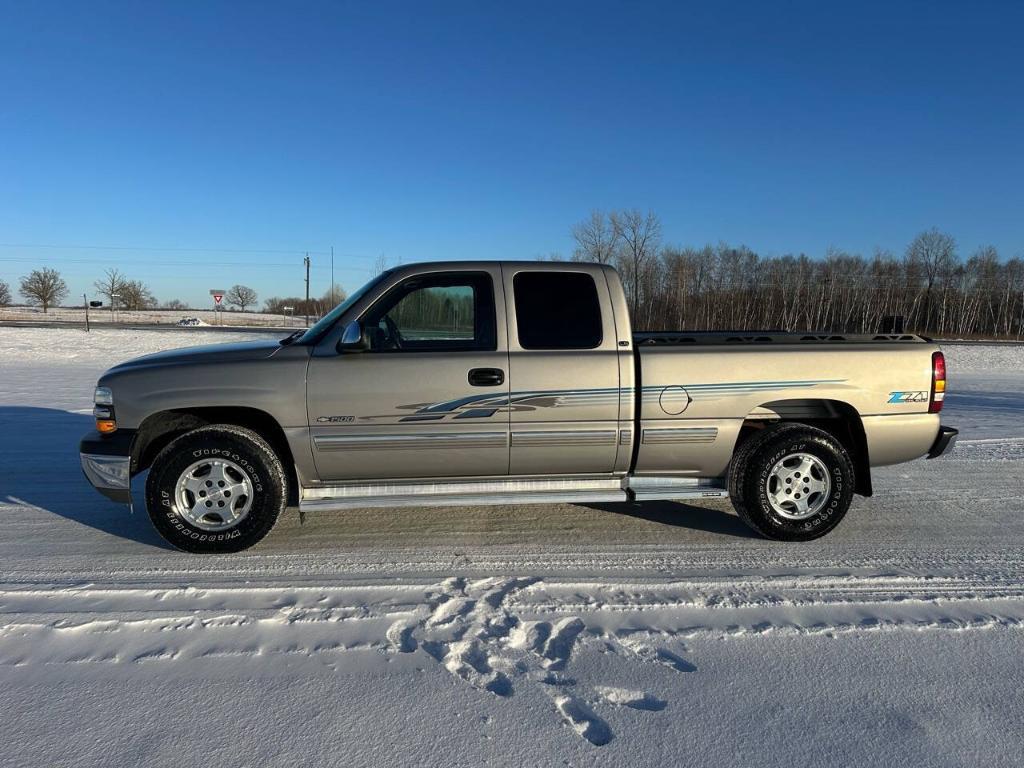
[{"left": 145, "top": 424, "right": 288, "bottom": 553}]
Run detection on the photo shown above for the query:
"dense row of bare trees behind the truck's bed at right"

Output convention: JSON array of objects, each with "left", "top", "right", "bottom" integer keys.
[{"left": 572, "top": 211, "right": 1024, "bottom": 339}]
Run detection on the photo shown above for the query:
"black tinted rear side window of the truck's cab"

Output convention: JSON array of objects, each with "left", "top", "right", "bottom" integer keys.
[{"left": 512, "top": 271, "right": 604, "bottom": 349}]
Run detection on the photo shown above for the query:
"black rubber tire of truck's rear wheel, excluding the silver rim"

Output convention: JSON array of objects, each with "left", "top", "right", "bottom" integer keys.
[{"left": 729, "top": 424, "right": 855, "bottom": 542}]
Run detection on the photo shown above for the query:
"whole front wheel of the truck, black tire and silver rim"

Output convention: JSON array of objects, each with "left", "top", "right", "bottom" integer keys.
[{"left": 145, "top": 424, "right": 288, "bottom": 552}]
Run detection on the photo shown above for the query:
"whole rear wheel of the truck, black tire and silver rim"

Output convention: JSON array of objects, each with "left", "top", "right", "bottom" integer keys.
[{"left": 729, "top": 424, "right": 854, "bottom": 542}]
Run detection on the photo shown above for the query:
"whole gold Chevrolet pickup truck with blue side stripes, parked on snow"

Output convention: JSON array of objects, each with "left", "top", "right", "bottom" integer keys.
[{"left": 81, "top": 261, "right": 956, "bottom": 552}]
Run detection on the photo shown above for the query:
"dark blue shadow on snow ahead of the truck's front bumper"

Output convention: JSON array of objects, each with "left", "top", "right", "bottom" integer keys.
[{"left": 0, "top": 406, "right": 169, "bottom": 549}]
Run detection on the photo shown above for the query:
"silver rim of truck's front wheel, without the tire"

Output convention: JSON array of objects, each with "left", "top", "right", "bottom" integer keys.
[{"left": 175, "top": 459, "right": 253, "bottom": 531}]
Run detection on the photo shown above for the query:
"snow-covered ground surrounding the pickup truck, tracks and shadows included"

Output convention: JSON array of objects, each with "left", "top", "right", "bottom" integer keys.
[{"left": 0, "top": 329, "right": 1024, "bottom": 766}]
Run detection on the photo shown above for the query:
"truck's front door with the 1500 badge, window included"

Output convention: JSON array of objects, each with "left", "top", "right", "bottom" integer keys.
[{"left": 307, "top": 266, "right": 509, "bottom": 482}]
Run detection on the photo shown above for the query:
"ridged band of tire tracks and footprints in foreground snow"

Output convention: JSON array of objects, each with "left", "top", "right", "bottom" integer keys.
[{"left": 6, "top": 572, "right": 1024, "bottom": 746}]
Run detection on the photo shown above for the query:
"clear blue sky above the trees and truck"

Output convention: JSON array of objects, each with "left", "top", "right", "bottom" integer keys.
[{"left": 0, "top": 2, "right": 1024, "bottom": 305}]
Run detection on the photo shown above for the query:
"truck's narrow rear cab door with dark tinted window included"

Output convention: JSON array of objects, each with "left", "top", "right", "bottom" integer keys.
[{"left": 503, "top": 264, "right": 631, "bottom": 475}]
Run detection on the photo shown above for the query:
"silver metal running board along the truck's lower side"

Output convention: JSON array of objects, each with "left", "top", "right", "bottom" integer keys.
[{"left": 299, "top": 477, "right": 728, "bottom": 512}]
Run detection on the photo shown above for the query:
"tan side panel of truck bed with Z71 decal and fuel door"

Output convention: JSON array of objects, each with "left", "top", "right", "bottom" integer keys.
[{"left": 636, "top": 342, "right": 939, "bottom": 477}]
